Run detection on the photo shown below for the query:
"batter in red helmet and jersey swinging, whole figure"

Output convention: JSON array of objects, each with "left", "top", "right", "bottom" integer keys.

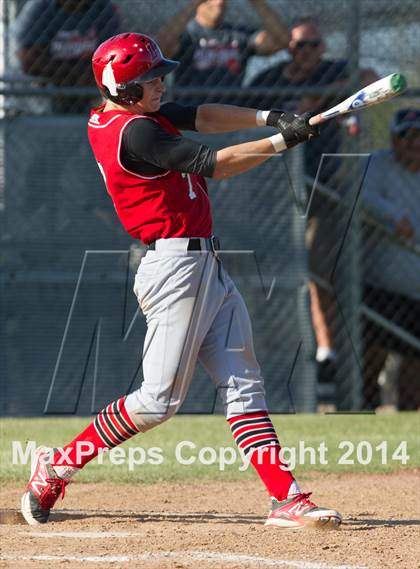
[{"left": 22, "top": 33, "right": 341, "bottom": 528}]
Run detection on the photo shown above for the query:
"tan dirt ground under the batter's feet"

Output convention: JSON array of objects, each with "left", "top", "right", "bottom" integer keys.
[{"left": 0, "top": 471, "right": 420, "bottom": 569}]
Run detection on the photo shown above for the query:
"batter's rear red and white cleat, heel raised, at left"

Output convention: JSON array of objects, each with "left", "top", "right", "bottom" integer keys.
[{"left": 21, "top": 447, "right": 69, "bottom": 526}]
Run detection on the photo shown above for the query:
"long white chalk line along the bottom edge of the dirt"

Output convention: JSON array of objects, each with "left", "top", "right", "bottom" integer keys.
[{"left": 0, "top": 551, "right": 368, "bottom": 569}]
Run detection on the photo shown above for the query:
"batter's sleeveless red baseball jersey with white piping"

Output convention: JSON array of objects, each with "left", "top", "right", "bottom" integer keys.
[{"left": 88, "top": 107, "right": 212, "bottom": 244}]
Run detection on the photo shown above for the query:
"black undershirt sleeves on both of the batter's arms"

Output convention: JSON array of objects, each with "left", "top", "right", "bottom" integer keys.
[{"left": 121, "top": 103, "right": 217, "bottom": 178}]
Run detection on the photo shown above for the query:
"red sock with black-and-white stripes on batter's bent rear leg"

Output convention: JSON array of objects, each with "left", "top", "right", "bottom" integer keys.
[{"left": 51, "top": 397, "right": 139, "bottom": 470}]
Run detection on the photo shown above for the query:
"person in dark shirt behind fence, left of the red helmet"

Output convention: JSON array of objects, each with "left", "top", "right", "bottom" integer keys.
[{"left": 15, "top": 0, "right": 119, "bottom": 112}]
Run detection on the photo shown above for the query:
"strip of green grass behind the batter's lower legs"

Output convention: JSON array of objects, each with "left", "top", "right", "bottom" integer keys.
[{"left": 0, "top": 413, "right": 420, "bottom": 483}]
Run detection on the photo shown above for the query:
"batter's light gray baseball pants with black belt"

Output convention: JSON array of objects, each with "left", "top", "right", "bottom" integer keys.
[{"left": 125, "top": 238, "right": 267, "bottom": 432}]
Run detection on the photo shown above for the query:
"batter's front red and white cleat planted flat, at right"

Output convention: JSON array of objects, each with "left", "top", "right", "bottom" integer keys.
[{"left": 265, "top": 492, "right": 342, "bottom": 529}]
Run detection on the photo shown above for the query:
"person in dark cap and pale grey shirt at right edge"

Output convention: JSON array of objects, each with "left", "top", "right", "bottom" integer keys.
[{"left": 362, "top": 109, "right": 420, "bottom": 410}]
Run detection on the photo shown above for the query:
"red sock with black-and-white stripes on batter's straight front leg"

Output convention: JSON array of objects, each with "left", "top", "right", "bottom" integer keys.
[{"left": 228, "top": 411, "right": 295, "bottom": 501}]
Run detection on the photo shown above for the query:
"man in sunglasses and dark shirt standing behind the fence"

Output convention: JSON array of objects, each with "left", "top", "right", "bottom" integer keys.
[{"left": 251, "top": 17, "right": 378, "bottom": 382}]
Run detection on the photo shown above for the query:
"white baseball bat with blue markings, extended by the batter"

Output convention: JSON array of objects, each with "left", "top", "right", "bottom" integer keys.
[{"left": 309, "top": 73, "right": 407, "bottom": 125}]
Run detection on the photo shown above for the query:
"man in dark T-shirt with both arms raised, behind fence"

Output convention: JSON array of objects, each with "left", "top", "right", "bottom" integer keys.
[{"left": 158, "top": 0, "right": 289, "bottom": 104}]
